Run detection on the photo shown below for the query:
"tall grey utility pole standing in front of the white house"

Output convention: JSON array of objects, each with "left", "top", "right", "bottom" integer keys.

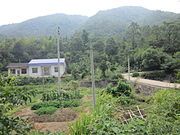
[{"left": 57, "top": 27, "right": 61, "bottom": 93}]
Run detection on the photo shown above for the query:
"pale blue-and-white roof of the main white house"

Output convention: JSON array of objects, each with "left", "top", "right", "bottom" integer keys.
[{"left": 28, "top": 58, "right": 65, "bottom": 65}]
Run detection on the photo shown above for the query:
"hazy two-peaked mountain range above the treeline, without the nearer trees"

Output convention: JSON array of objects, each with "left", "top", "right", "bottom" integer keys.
[{"left": 0, "top": 6, "right": 180, "bottom": 37}]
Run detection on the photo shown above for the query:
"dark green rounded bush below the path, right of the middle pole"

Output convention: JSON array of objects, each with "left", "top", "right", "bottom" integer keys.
[{"left": 107, "top": 81, "right": 131, "bottom": 96}]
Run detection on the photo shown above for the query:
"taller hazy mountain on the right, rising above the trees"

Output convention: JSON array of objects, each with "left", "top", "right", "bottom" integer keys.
[{"left": 83, "top": 6, "right": 180, "bottom": 35}]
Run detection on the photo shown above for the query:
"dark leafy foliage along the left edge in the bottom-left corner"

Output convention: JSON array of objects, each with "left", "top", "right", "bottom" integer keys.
[{"left": 0, "top": 76, "right": 35, "bottom": 135}]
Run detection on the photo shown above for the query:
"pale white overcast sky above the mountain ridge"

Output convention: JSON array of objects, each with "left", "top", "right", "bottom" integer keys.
[{"left": 0, "top": 0, "right": 180, "bottom": 25}]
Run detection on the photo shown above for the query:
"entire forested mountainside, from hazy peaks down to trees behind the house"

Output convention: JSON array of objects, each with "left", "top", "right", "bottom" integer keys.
[{"left": 0, "top": 7, "right": 180, "bottom": 79}]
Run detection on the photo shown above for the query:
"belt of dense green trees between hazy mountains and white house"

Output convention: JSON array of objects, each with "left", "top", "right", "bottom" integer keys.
[{"left": 0, "top": 21, "right": 180, "bottom": 81}]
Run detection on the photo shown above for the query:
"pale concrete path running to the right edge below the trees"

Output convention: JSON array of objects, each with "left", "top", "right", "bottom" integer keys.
[{"left": 122, "top": 74, "right": 180, "bottom": 88}]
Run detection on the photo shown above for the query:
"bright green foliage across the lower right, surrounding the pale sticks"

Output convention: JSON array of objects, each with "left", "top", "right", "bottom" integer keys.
[{"left": 71, "top": 89, "right": 180, "bottom": 135}]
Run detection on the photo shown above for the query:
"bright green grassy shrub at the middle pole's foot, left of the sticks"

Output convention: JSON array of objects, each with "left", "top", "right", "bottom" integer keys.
[{"left": 70, "top": 93, "right": 116, "bottom": 135}]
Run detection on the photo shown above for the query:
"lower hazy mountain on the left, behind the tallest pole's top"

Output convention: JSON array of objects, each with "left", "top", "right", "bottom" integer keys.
[{"left": 0, "top": 14, "right": 88, "bottom": 37}]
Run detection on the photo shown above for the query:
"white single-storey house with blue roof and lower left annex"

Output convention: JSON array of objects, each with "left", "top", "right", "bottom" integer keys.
[{"left": 7, "top": 58, "right": 66, "bottom": 77}]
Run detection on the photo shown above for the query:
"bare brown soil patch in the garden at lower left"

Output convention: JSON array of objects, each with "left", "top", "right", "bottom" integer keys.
[{"left": 15, "top": 108, "right": 78, "bottom": 132}]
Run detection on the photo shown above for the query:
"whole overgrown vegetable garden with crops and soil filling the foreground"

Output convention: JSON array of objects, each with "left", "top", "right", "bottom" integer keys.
[{"left": 0, "top": 76, "right": 180, "bottom": 135}]
